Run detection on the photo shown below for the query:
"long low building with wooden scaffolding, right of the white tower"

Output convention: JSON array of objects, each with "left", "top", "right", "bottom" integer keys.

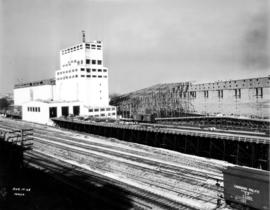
[{"left": 111, "top": 76, "right": 270, "bottom": 118}]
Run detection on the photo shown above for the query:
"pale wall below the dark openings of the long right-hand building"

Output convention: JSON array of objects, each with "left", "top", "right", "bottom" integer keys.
[{"left": 190, "top": 87, "right": 270, "bottom": 117}]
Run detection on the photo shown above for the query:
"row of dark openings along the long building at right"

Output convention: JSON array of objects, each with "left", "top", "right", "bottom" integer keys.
[{"left": 188, "top": 88, "right": 263, "bottom": 98}]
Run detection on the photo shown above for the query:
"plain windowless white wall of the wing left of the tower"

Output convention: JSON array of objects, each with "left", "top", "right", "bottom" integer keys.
[{"left": 13, "top": 85, "right": 54, "bottom": 106}]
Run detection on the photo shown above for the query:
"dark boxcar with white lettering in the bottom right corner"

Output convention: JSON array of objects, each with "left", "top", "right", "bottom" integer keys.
[{"left": 223, "top": 166, "right": 270, "bottom": 210}]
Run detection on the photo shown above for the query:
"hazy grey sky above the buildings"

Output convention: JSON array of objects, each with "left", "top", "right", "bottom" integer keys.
[{"left": 0, "top": 0, "right": 270, "bottom": 93}]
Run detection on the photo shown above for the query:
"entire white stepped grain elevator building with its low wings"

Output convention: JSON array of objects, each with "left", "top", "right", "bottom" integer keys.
[{"left": 14, "top": 33, "right": 116, "bottom": 124}]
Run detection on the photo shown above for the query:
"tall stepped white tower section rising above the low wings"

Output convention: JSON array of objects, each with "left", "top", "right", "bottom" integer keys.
[{"left": 55, "top": 41, "right": 109, "bottom": 106}]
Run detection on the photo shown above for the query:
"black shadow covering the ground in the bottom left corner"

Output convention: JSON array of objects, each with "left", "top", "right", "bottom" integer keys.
[{"left": 0, "top": 143, "right": 133, "bottom": 210}]
